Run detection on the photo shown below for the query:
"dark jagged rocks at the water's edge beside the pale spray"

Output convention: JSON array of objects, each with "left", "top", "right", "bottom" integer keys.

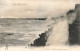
[{"left": 31, "top": 32, "right": 47, "bottom": 46}]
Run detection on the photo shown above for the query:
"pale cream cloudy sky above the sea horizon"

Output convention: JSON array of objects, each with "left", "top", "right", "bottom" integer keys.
[{"left": 0, "top": 0, "right": 80, "bottom": 17}]
